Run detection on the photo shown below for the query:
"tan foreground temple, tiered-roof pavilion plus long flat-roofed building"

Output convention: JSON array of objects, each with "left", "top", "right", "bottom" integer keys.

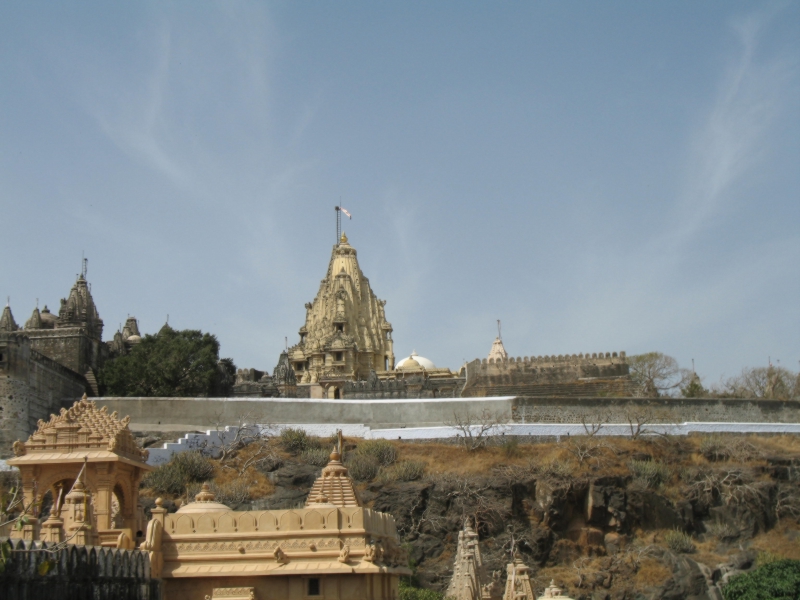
[{"left": 8, "top": 397, "right": 411, "bottom": 600}]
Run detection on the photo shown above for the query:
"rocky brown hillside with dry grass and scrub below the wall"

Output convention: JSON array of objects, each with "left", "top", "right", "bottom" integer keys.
[{"left": 138, "top": 430, "right": 800, "bottom": 599}]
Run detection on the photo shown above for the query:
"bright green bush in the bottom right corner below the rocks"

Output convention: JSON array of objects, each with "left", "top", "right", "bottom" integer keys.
[{"left": 722, "top": 559, "right": 800, "bottom": 600}]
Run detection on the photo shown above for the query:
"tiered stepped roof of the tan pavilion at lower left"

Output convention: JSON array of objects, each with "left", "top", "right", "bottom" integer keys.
[{"left": 12, "top": 394, "right": 149, "bottom": 464}]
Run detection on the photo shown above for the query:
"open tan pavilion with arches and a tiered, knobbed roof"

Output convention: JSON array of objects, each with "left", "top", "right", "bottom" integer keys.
[{"left": 8, "top": 395, "right": 154, "bottom": 549}]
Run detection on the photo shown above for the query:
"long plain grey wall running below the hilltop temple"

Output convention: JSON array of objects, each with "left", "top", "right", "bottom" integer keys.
[{"left": 83, "top": 396, "right": 800, "bottom": 431}]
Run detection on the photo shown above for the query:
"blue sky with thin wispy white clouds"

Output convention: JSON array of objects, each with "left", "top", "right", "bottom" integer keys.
[{"left": 0, "top": 0, "right": 800, "bottom": 385}]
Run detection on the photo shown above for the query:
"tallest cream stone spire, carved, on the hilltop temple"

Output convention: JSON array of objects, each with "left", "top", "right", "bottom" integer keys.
[{"left": 289, "top": 234, "right": 394, "bottom": 383}]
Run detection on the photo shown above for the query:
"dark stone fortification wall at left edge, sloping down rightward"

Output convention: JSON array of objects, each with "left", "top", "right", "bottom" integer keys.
[{"left": 0, "top": 334, "right": 86, "bottom": 456}]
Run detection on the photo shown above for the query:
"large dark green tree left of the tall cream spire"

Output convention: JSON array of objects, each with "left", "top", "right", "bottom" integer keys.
[{"left": 98, "top": 327, "right": 236, "bottom": 397}]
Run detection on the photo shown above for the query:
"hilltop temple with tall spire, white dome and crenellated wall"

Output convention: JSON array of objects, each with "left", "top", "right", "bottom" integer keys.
[{"left": 234, "top": 234, "right": 631, "bottom": 400}]
